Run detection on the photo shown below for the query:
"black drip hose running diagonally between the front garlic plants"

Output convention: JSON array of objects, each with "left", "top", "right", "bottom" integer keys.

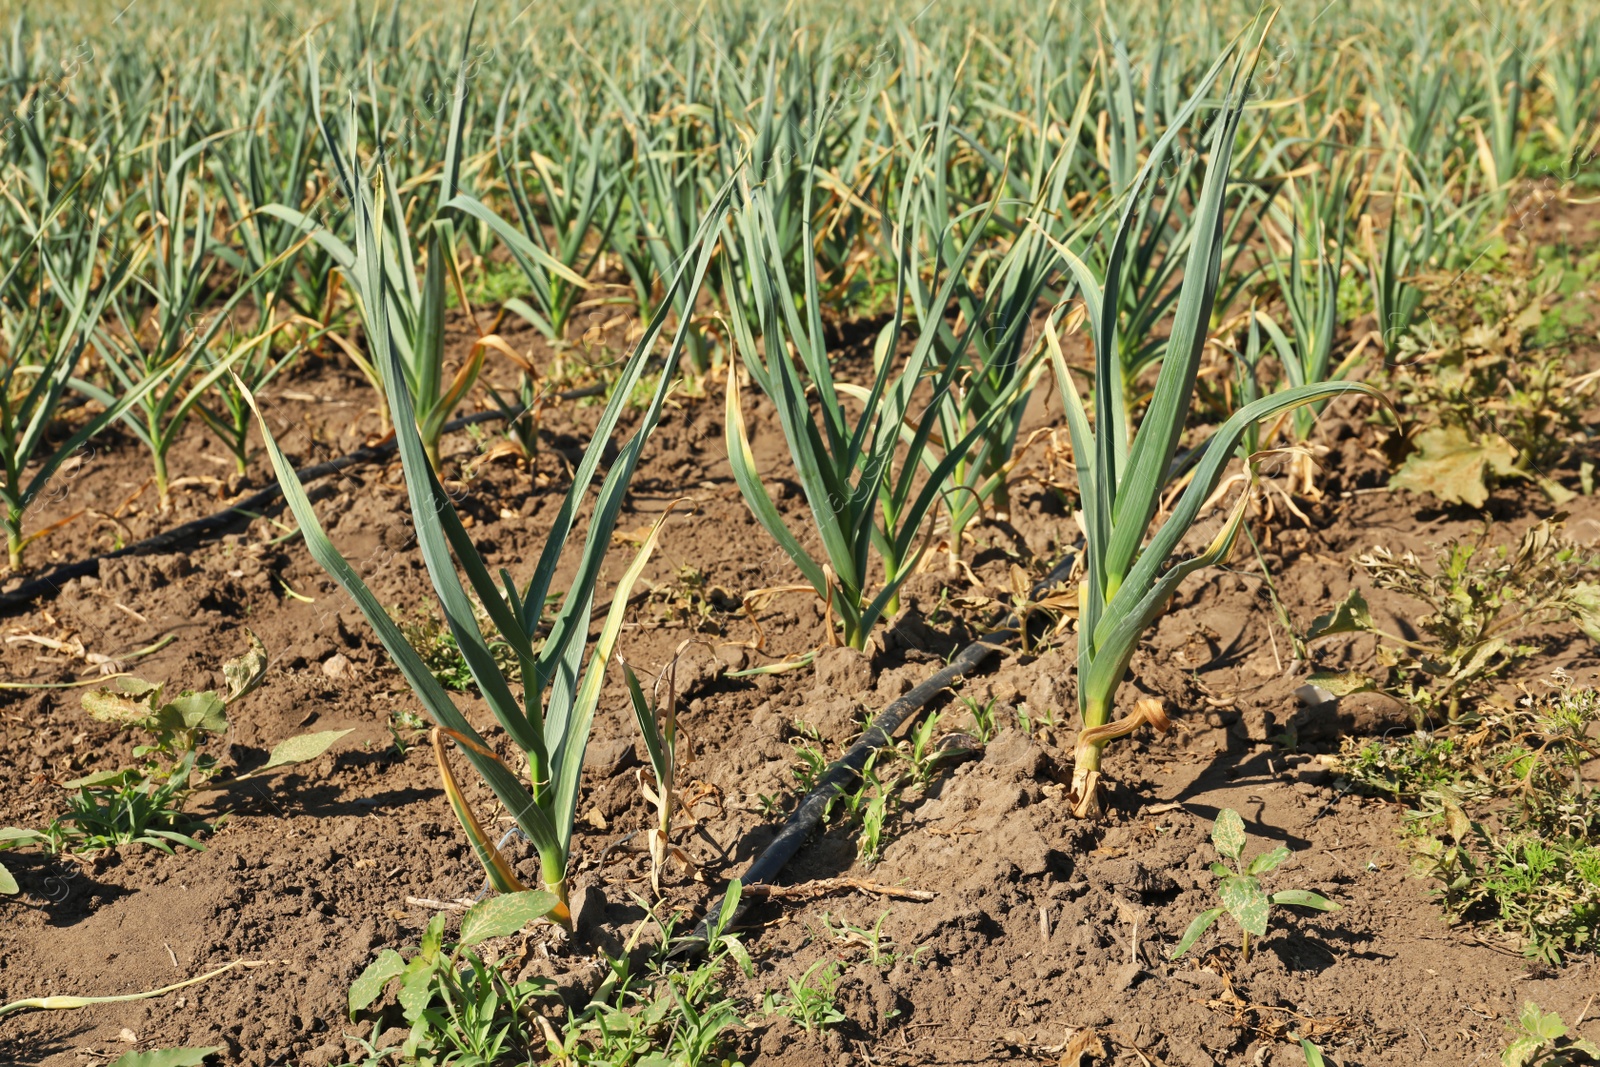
[{"left": 670, "top": 550, "right": 1078, "bottom": 958}]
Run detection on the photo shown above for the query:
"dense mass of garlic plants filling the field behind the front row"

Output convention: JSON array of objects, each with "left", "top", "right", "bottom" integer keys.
[{"left": 0, "top": 5, "right": 1600, "bottom": 568}]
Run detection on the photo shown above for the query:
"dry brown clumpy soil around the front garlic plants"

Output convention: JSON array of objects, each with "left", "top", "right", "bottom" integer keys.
[{"left": 0, "top": 238, "right": 1600, "bottom": 1067}]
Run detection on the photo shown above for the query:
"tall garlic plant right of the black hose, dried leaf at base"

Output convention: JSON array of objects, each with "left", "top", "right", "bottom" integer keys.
[{"left": 1046, "top": 20, "right": 1381, "bottom": 816}]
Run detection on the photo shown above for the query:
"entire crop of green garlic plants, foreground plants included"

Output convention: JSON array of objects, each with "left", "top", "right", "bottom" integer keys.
[{"left": 0, "top": 3, "right": 1594, "bottom": 918}]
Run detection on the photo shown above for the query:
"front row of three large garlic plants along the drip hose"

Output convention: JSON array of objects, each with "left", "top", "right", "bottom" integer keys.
[{"left": 240, "top": 8, "right": 1324, "bottom": 926}]
